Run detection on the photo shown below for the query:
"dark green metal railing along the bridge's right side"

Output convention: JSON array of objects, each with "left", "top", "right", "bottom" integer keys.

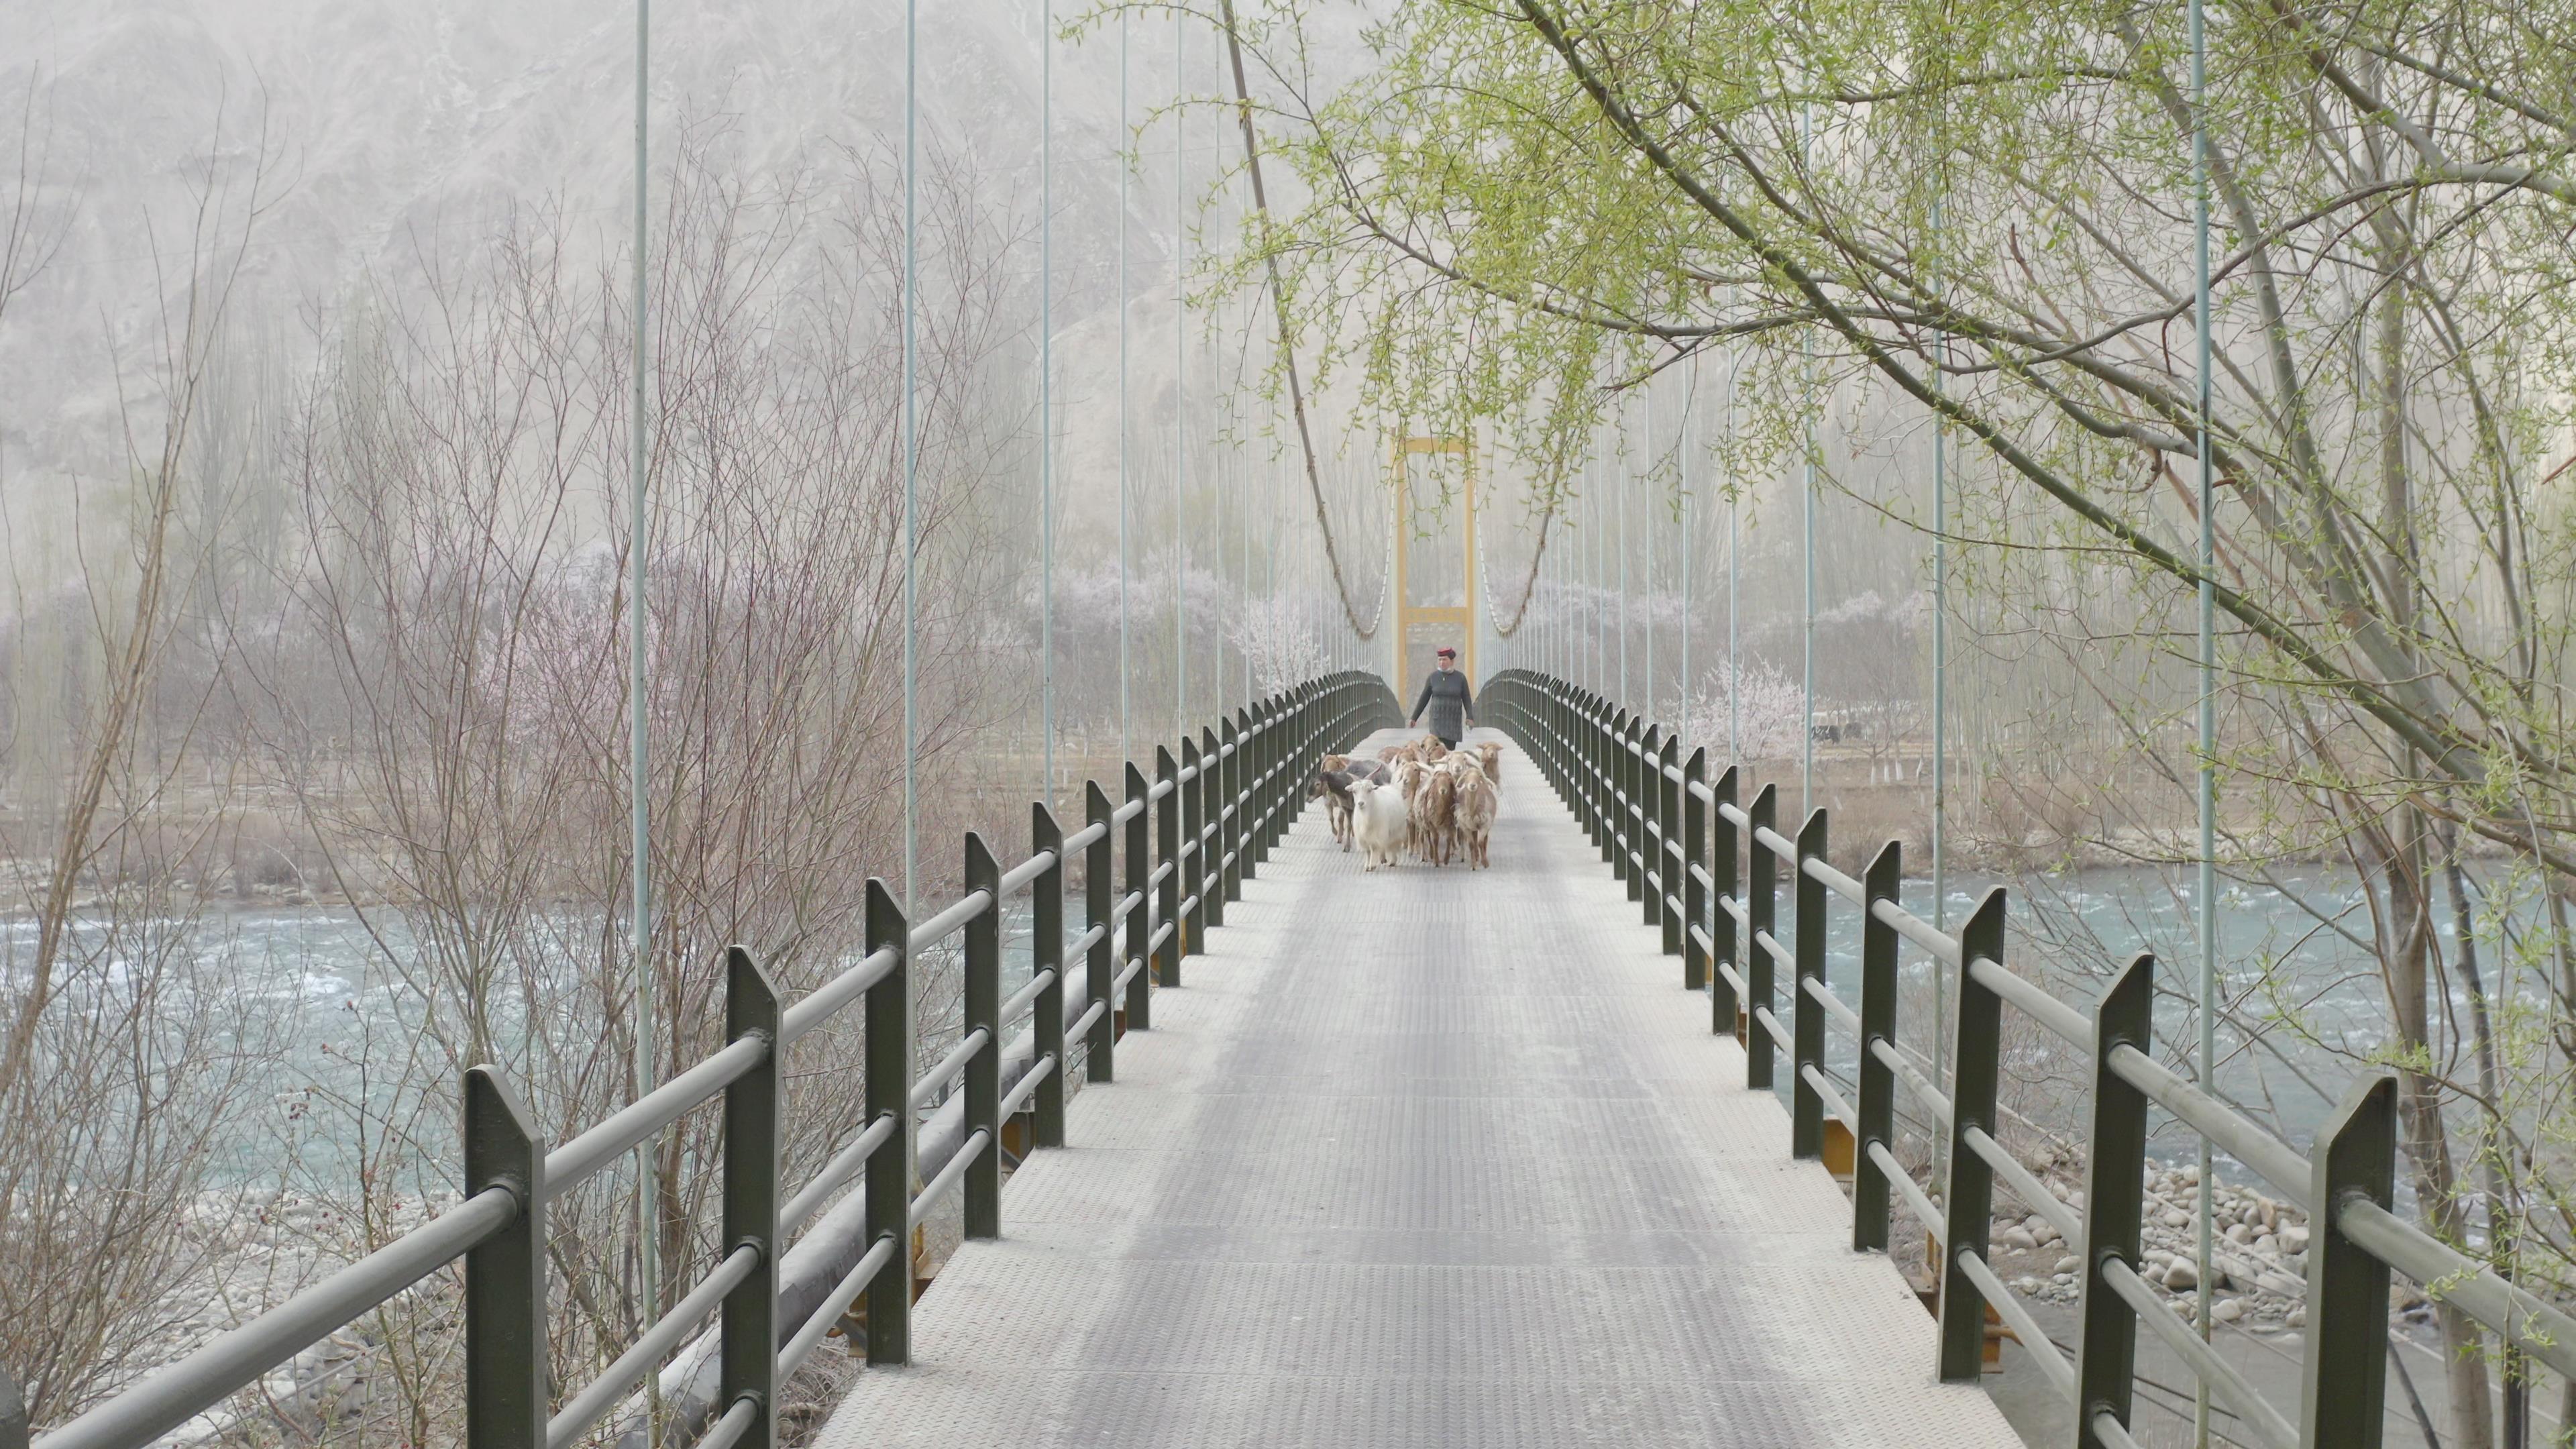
[{"left": 1484, "top": 670, "right": 2576, "bottom": 1449}]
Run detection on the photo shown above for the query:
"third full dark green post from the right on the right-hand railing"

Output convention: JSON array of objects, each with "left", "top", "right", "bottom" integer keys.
[{"left": 1940, "top": 887, "right": 2004, "bottom": 1385}]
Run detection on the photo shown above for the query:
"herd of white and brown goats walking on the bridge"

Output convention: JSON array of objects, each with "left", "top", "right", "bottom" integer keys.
[{"left": 1306, "top": 737, "right": 1502, "bottom": 871}]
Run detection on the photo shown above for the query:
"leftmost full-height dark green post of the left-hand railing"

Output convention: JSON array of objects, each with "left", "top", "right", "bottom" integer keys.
[{"left": 464, "top": 1067, "right": 543, "bottom": 1449}]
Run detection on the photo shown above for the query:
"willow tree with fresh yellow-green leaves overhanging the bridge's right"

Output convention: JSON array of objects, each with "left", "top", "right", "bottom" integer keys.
[{"left": 1221, "top": 0, "right": 2576, "bottom": 1446}]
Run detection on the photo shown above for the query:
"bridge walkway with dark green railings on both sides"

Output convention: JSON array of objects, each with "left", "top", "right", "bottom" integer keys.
[{"left": 0, "top": 670, "right": 2576, "bottom": 1449}]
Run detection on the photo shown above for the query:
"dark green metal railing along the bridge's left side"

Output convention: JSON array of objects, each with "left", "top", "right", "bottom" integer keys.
[{"left": 0, "top": 670, "right": 1399, "bottom": 1449}]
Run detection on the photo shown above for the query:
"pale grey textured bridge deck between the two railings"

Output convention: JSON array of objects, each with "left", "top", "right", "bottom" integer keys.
[{"left": 822, "top": 732, "right": 2017, "bottom": 1449}]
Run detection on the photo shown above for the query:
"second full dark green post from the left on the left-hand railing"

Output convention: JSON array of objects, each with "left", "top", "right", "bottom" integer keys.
[{"left": 716, "top": 947, "right": 778, "bottom": 1449}]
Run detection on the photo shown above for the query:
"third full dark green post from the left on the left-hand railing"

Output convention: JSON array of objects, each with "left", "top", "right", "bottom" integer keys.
[{"left": 861, "top": 877, "right": 912, "bottom": 1366}]
